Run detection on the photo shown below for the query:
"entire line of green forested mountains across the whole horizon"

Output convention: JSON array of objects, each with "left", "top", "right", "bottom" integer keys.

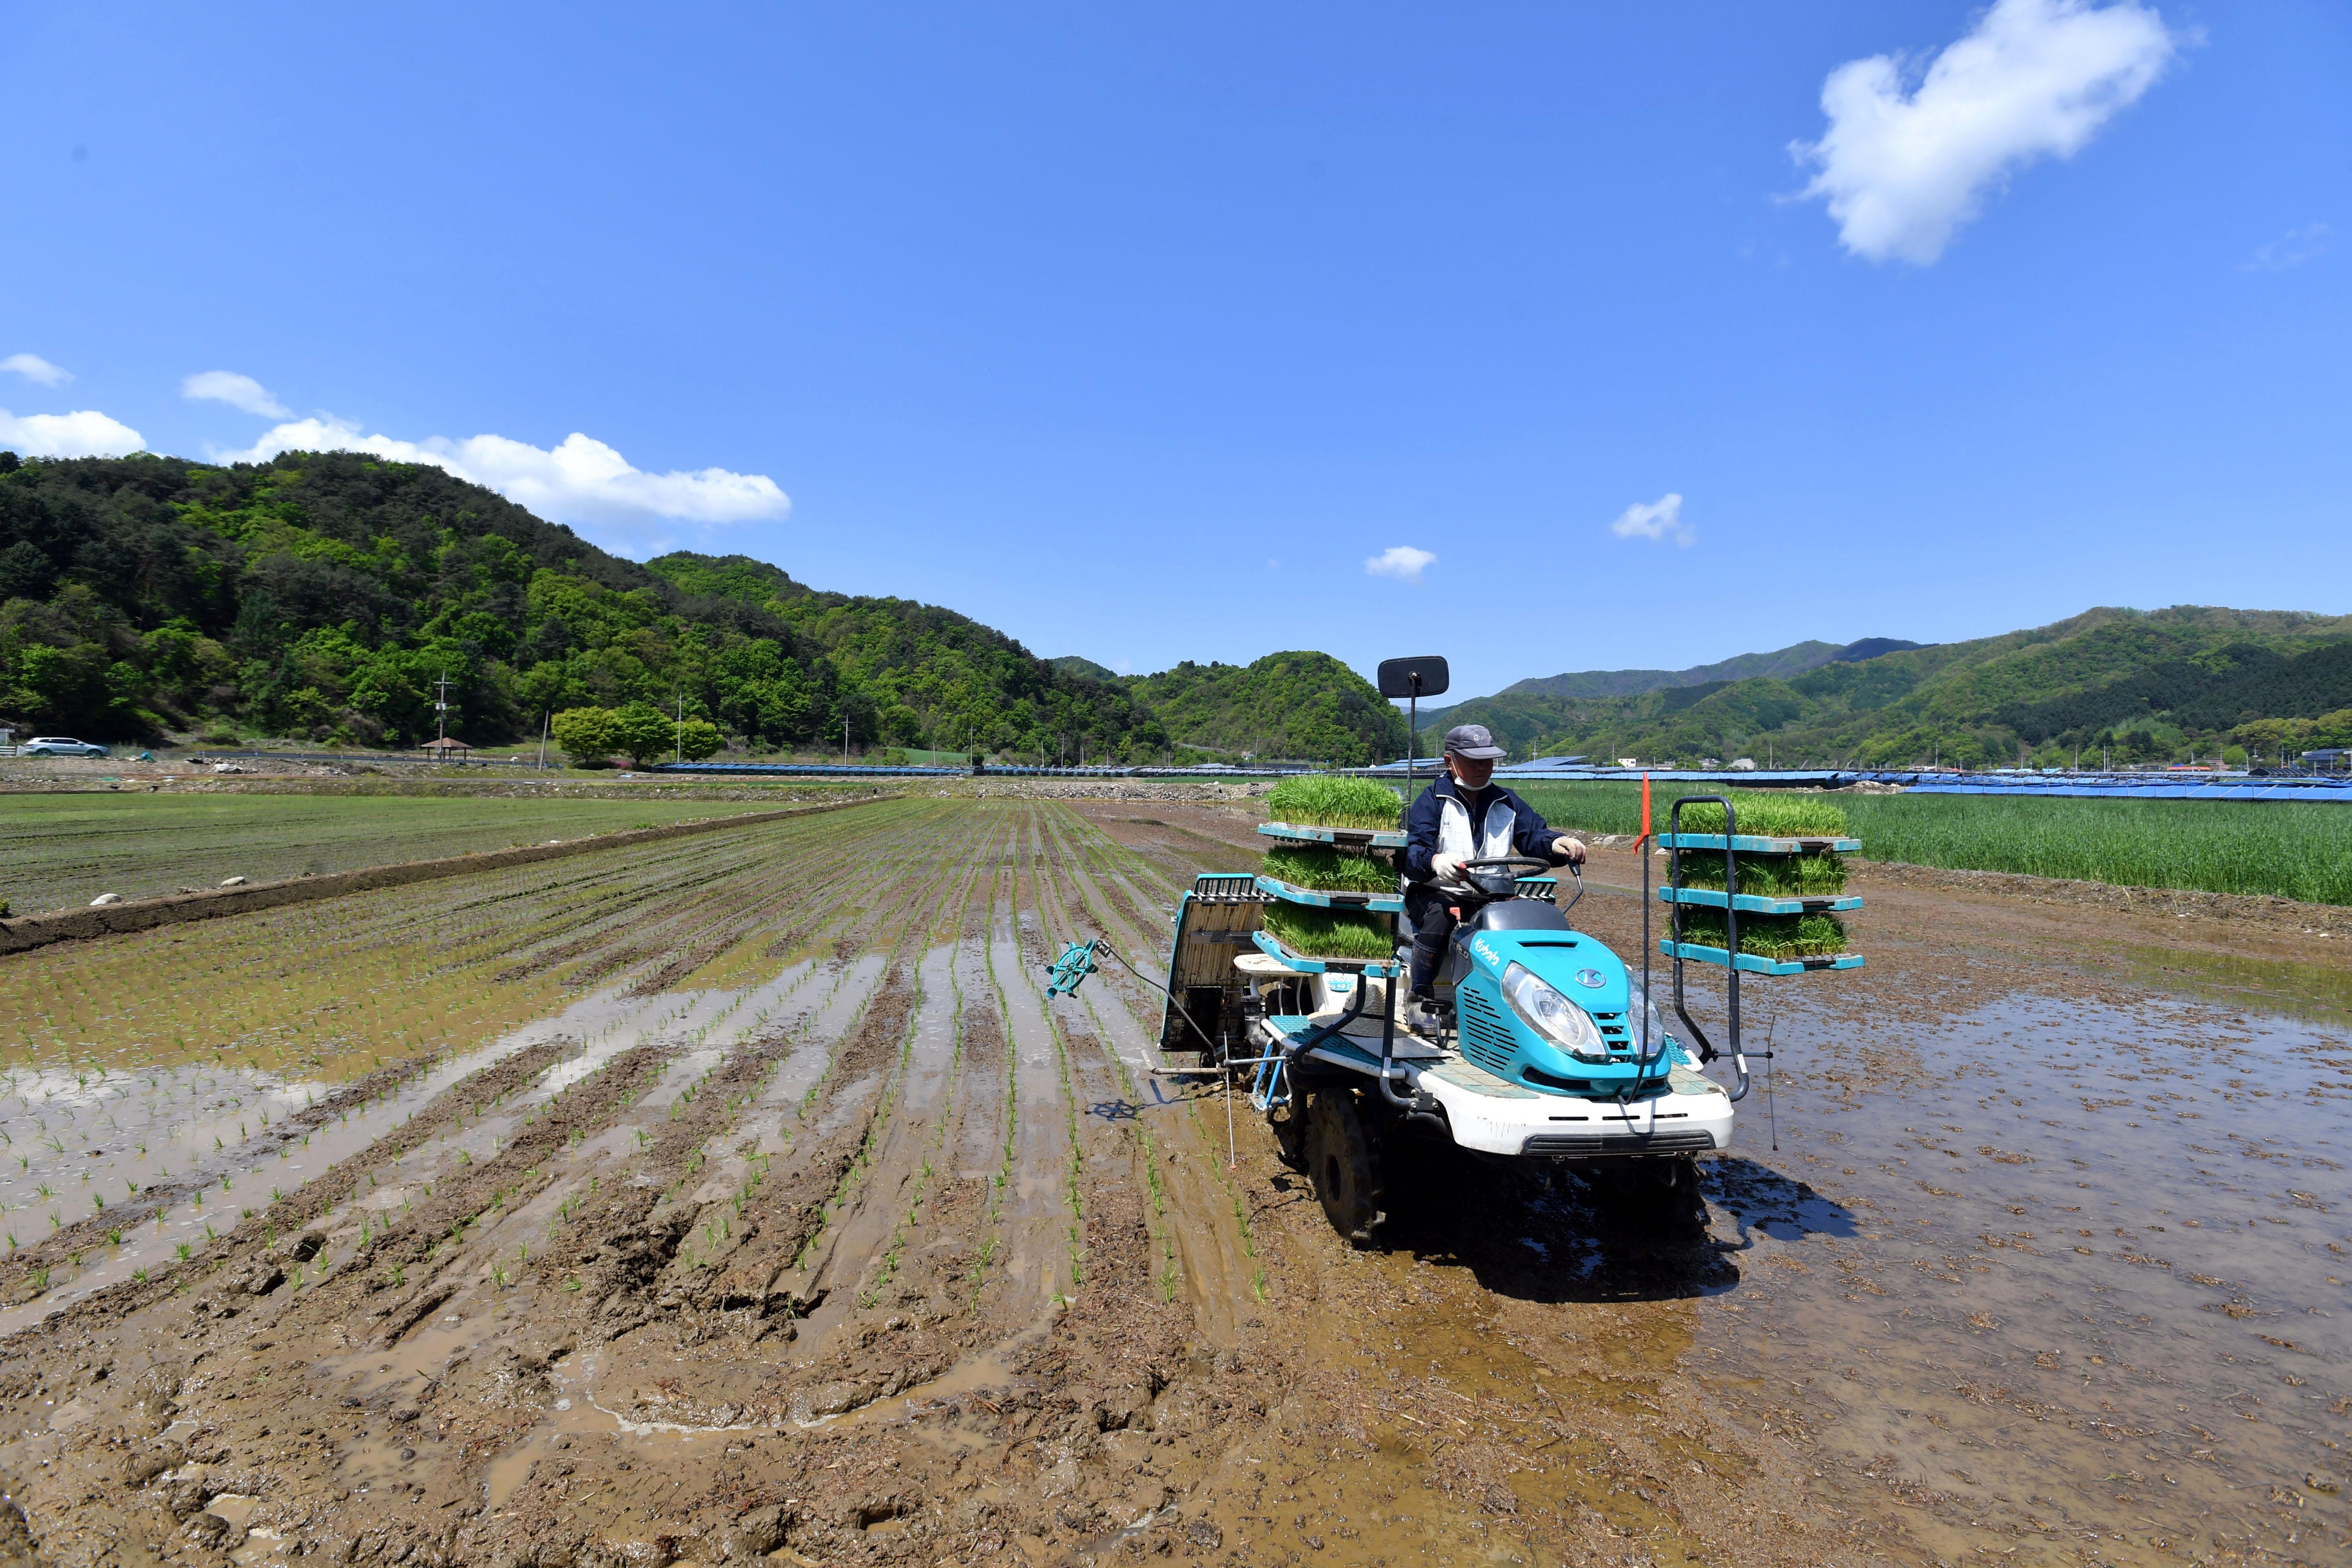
[{"left": 14, "top": 454, "right": 2352, "bottom": 764}]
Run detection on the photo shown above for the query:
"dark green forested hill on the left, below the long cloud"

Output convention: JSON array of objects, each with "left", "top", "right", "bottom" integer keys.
[{"left": 0, "top": 452, "right": 1402, "bottom": 760}]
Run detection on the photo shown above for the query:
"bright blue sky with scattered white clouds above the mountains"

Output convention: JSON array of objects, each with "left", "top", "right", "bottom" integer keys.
[{"left": 0, "top": 0, "right": 2352, "bottom": 696}]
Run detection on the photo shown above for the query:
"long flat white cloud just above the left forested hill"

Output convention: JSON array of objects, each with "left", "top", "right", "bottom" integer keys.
[{"left": 221, "top": 416, "right": 792, "bottom": 548}]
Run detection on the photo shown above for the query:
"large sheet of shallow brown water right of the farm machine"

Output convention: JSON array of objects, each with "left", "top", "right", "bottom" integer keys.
[{"left": 1701, "top": 983, "right": 2352, "bottom": 1563}]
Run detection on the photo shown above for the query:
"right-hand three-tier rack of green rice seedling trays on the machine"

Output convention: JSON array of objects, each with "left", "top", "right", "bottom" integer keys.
[{"left": 1642, "top": 795, "right": 1863, "bottom": 1100}]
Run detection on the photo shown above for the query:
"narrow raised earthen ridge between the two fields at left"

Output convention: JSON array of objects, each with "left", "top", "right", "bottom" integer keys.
[{"left": 0, "top": 792, "right": 889, "bottom": 957}]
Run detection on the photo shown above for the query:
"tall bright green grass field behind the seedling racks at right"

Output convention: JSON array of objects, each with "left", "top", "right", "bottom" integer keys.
[{"left": 1519, "top": 781, "right": 2352, "bottom": 905}]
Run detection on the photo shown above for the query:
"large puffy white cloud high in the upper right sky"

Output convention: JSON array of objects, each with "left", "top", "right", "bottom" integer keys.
[{"left": 1790, "top": 0, "right": 2190, "bottom": 266}]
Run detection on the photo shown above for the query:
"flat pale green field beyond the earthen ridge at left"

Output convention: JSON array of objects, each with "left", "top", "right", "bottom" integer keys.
[{"left": 0, "top": 790, "right": 802, "bottom": 915}]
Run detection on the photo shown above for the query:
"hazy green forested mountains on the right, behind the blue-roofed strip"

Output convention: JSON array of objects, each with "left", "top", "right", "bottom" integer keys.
[{"left": 1423, "top": 604, "right": 2352, "bottom": 766}]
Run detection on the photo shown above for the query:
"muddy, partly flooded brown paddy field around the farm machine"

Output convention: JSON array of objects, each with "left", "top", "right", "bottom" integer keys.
[{"left": 0, "top": 795, "right": 2352, "bottom": 1565}]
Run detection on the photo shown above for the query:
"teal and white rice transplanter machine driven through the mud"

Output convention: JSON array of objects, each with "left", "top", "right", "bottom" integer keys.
[{"left": 1051, "top": 658, "right": 1860, "bottom": 1246}]
